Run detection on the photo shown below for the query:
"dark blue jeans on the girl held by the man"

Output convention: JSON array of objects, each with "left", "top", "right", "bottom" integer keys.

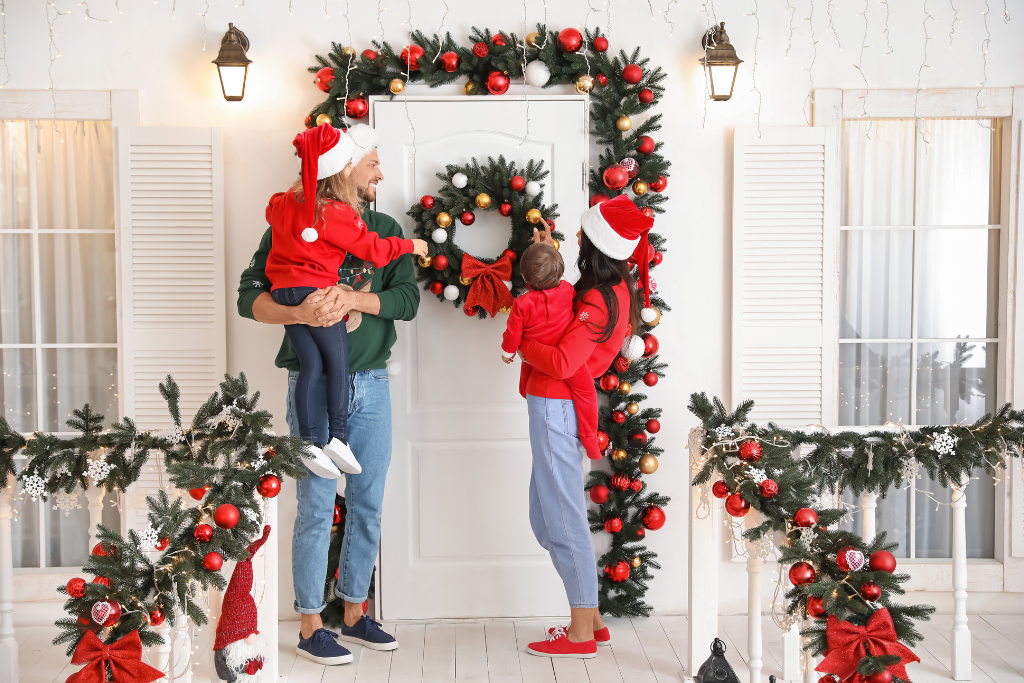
[{"left": 270, "top": 287, "right": 348, "bottom": 444}]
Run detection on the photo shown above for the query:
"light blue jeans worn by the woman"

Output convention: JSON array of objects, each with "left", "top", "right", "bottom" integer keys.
[{"left": 526, "top": 394, "right": 597, "bottom": 608}]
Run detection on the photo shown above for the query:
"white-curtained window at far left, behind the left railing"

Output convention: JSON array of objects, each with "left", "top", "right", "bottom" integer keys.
[{"left": 0, "top": 120, "right": 120, "bottom": 567}]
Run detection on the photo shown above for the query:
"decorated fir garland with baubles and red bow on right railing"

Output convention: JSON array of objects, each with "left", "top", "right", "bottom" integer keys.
[{"left": 689, "top": 393, "right": 1024, "bottom": 683}]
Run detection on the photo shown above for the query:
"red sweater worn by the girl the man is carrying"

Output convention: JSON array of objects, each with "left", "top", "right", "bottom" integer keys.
[{"left": 266, "top": 189, "right": 413, "bottom": 290}]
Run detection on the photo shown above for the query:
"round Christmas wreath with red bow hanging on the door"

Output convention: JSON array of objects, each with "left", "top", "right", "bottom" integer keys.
[{"left": 408, "top": 157, "right": 562, "bottom": 318}]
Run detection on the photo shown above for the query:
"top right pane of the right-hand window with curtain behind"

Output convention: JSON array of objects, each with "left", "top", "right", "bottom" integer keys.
[{"left": 915, "top": 119, "right": 993, "bottom": 225}]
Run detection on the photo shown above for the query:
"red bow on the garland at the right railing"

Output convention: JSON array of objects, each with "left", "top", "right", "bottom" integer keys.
[{"left": 815, "top": 607, "right": 921, "bottom": 681}]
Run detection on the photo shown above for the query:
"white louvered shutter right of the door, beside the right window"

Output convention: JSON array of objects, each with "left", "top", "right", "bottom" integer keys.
[{"left": 732, "top": 127, "right": 839, "bottom": 427}]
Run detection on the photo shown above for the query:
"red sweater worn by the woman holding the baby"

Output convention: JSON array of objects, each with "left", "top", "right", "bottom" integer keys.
[{"left": 519, "top": 282, "right": 630, "bottom": 398}]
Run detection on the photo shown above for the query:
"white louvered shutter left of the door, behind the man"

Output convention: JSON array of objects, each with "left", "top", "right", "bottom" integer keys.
[{"left": 115, "top": 127, "right": 227, "bottom": 529}]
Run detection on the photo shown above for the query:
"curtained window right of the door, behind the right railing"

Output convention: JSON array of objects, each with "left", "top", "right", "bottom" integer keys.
[{"left": 839, "top": 119, "right": 1001, "bottom": 558}]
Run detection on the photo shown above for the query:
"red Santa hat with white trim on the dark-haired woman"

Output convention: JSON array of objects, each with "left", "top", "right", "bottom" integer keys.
[{"left": 581, "top": 195, "right": 654, "bottom": 306}]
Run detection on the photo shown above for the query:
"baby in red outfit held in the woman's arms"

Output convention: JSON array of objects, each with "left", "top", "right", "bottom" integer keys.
[{"left": 502, "top": 244, "right": 601, "bottom": 460}]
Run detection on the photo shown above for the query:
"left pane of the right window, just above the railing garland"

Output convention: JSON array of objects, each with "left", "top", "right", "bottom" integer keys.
[{"left": 839, "top": 344, "right": 910, "bottom": 426}]
